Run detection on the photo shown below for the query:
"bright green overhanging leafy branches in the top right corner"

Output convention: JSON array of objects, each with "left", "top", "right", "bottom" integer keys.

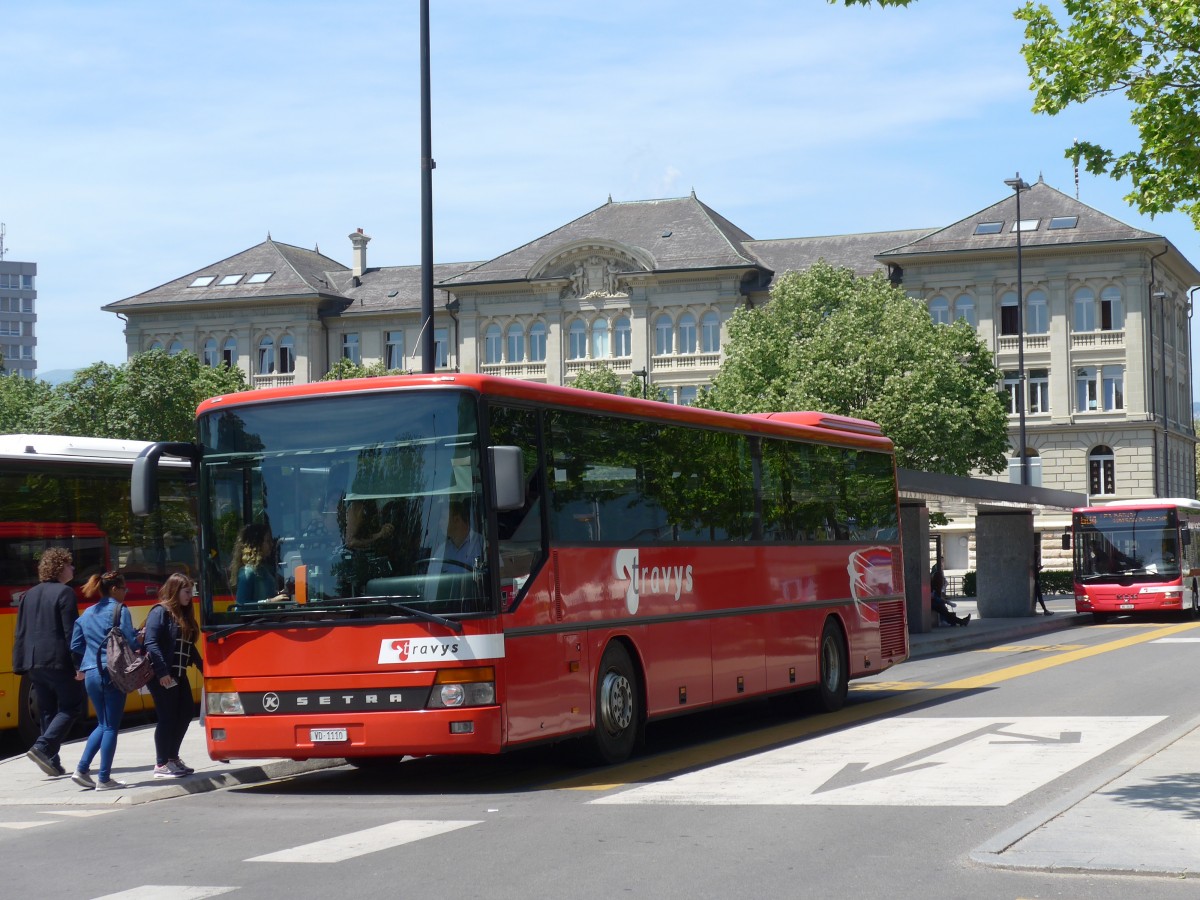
[{"left": 829, "top": 0, "right": 1200, "bottom": 227}]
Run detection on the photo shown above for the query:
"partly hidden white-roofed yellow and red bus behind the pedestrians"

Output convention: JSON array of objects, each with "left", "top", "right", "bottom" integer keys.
[{"left": 0, "top": 434, "right": 199, "bottom": 744}]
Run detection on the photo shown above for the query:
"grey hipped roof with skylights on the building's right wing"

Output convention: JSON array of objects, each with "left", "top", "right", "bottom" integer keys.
[{"left": 880, "top": 179, "right": 1162, "bottom": 262}]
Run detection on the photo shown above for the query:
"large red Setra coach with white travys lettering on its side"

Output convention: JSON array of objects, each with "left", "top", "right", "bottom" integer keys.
[{"left": 133, "top": 374, "right": 908, "bottom": 763}]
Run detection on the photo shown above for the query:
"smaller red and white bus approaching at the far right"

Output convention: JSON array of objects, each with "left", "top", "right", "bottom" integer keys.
[{"left": 1072, "top": 499, "right": 1200, "bottom": 622}]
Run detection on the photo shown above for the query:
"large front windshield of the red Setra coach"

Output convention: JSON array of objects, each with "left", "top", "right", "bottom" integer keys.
[{"left": 199, "top": 390, "right": 491, "bottom": 628}]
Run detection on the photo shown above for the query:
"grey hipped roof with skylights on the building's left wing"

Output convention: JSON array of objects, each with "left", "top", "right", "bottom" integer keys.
[{"left": 103, "top": 238, "right": 349, "bottom": 312}]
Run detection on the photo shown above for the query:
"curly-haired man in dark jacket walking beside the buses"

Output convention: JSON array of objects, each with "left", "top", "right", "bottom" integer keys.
[{"left": 12, "top": 547, "right": 86, "bottom": 775}]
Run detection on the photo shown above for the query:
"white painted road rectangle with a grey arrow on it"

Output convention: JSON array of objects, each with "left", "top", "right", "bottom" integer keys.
[{"left": 592, "top": 715, "right": 1165, "bottom": 806}]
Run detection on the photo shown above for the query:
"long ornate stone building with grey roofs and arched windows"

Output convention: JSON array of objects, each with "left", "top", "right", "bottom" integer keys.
[{"left": 104, "top": 181, "right": 1200, "bottom": 569}]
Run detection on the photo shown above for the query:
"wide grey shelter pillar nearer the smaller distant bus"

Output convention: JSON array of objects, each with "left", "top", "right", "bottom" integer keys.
[{"left": 976, "top": 510, "right": 1034, "bottom": 619}]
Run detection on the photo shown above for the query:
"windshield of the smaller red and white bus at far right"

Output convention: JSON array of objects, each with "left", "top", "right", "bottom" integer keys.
[{"left": 1075, "top": 509, "right": 1180, "bottom": 583}]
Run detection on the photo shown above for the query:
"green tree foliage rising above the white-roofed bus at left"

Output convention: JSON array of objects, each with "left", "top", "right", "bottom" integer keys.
[{"left": 0, "top": 350, "right": 246, "bottom": 440}]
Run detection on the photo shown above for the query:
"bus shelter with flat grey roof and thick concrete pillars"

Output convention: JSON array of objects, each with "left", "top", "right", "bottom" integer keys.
[{"left": 898, "top": 469, "right": 1087, "bottom": 632}]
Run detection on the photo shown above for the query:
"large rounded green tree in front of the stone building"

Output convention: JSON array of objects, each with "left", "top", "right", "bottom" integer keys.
[{"left": 701, "top": 262, "right": 1009, "bottom": 475}]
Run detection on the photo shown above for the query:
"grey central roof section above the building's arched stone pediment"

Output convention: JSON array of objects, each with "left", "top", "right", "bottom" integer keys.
[{"left": 440, "top": 193, "right": 760, "bottom": 290}]
